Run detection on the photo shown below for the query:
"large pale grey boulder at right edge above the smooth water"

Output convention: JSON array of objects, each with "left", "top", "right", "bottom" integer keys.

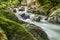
[{"left": 48, "top": 9, "right": 60, "bottom": 23}]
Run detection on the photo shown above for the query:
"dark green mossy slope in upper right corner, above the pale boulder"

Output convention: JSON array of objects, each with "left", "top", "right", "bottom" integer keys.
[{"left": 38, "top": 0, "right": 60, "bottom": 16}]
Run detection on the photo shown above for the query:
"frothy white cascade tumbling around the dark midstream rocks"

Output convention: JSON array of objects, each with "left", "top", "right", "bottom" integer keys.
[{"left": 14, "top": 7, "right": 35, "bottom": 21}]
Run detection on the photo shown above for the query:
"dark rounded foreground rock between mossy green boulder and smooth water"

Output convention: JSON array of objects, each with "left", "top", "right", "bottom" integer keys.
[{"left": 21, "top": 23, "right": 49, "bottom": 40}]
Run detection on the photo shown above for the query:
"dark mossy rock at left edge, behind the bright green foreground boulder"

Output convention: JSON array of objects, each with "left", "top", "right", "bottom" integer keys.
[{"left": 0, "top": 8, "right": 19, "bottom": 22}]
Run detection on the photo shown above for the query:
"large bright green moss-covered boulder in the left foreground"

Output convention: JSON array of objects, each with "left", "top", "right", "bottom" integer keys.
[{"left": 0, "top": 17, "right": 36, "bottom": 40}]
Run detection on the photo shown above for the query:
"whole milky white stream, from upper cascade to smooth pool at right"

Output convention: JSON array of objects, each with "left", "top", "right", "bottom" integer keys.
[{"left": 15, "top": 7, "right": 60, "bottom": 40}]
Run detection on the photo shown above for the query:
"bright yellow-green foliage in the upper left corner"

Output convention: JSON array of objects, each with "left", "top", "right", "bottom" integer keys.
[{"left": 0, "top": 0, "right": 22, "bottom": 6}]
